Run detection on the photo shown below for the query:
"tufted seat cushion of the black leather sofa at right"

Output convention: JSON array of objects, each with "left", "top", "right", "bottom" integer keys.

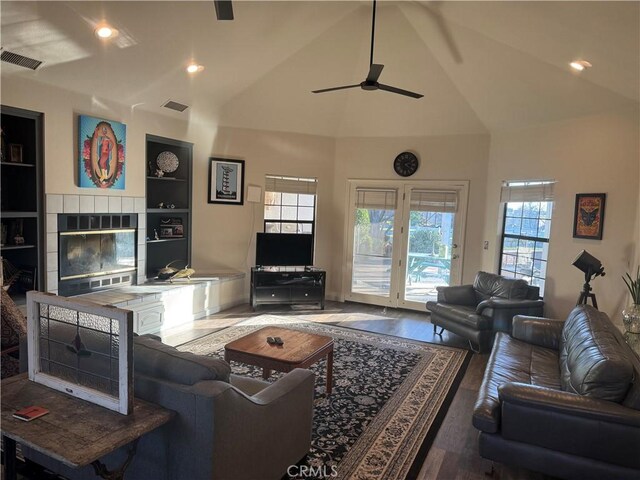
[{"left": 473, "top": 332, "right": 560, "bottom": 433}]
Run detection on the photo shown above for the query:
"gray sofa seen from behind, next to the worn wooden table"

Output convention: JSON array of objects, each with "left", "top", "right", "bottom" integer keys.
[{"left": 24, "top": 335, "right": 315, "bottom": 480}]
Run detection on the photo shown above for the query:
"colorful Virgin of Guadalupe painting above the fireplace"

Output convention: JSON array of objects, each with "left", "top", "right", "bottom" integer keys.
[{"left": 78, "top": 115, "right": 127, "bottom": 190}]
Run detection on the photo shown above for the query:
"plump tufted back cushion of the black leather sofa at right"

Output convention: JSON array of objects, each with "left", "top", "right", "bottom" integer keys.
[{"left": 560, "top": 305, "right": 633, "bottom": 402}]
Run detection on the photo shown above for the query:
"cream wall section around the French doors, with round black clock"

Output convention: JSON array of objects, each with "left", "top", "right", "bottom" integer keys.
[{"left": 328, "top": 135, "right": 489, "bottom": 293}]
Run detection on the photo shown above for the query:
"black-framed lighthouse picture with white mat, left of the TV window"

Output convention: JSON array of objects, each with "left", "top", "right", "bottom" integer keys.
[{"left": 207, "top": 157, "right": 244, "bottom": 205}]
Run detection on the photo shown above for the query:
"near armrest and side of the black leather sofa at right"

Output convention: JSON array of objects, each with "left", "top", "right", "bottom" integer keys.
[{"left": 498, "top": 383, "right": 640, "bottom": 468}]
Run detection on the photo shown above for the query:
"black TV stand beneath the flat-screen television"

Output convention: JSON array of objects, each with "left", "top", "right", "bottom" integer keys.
[{"left": 251, "top": 267, "right": 327, "bottom": 310}]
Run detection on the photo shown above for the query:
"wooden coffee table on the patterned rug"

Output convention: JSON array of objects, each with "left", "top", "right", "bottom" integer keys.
[{"left": 224, "top": 327, "right": 333, "bottom": 394}]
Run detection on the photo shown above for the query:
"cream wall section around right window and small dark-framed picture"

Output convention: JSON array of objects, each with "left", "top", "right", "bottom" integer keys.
[{"left": 482, "top": 110, "right": 640, "bottom": 324}]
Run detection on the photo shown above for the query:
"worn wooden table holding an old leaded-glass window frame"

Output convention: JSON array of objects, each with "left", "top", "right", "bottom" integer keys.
[{"left": 0, "top": 374, "right": 173, "bottom": 480}]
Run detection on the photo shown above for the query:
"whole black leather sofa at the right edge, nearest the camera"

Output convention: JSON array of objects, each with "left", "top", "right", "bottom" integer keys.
[{"left": 473, "top": 305, "right": 640, "bottom": 480}]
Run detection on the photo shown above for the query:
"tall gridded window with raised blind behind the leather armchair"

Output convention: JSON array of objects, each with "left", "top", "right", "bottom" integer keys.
[{"left": 500, "top": 180, "right": 555, "bottom": 296}]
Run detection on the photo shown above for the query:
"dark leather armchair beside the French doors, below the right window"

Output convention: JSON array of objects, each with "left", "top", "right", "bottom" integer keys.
[{"left": 427, "top": 272, "right": 544, "bottom": 353}]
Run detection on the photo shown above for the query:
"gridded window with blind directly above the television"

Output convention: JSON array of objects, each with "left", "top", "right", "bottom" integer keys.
[{"left": 264, "top": 175, "right": 318, "bottom": 235}]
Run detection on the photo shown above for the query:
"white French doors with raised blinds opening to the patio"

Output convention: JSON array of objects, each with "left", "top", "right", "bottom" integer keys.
[{"left": 343, "top": 180, "right": 469, "bottom": 310}]
